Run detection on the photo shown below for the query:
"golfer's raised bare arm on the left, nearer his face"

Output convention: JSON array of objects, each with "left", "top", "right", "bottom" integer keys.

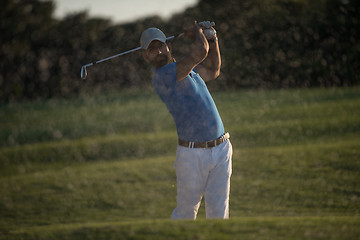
[{"left": 176, "top": 28, "right": 209, "bottom": 81}]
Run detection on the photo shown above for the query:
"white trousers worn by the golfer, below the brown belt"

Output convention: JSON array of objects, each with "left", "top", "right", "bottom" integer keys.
[{"left": 171, "top": 140, "right": 232, "bottom": 219}]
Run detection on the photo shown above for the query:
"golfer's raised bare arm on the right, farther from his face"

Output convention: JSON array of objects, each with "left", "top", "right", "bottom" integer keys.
[{"left": 197, "top": 38, "right": 221, "bottom": 82}]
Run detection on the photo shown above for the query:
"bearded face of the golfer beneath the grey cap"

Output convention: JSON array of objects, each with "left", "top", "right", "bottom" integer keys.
[{"left": 146, "top": 40, "right": 171, "bottom": 68}]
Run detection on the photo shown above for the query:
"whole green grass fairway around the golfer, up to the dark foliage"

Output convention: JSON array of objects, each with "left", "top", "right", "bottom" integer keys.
[{"left": 0, "top": 87, "right": 360, "bottom": 239}]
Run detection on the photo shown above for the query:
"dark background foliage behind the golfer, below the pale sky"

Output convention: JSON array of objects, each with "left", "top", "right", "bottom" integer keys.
[{"left": 0, "top": 0, "right": 360, "bottom": 102}]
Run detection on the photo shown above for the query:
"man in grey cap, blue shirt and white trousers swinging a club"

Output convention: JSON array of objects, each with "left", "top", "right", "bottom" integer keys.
[{"left": 140, "top": 21, "right": 232, "bottom": 219}]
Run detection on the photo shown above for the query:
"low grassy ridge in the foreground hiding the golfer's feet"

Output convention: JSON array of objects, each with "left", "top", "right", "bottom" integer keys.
[{"left": 10, "top": 217, "right": 360, "bottom": 240}]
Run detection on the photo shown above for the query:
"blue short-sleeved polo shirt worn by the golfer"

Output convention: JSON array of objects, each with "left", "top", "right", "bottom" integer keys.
[{"left": 152, "top": 62, "right": 225, "bottom": 142}]
